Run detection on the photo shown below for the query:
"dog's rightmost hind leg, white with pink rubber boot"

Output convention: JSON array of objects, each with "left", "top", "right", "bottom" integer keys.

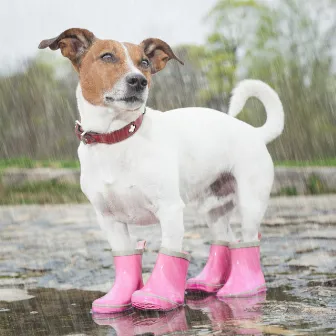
[{"left": 217, "top": 161, "right": 273, "bottom": 298}]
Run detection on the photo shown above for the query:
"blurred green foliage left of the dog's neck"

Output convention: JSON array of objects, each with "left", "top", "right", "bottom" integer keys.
[{"left": 0, "top": 60, "right": 77, "bottom": 158}]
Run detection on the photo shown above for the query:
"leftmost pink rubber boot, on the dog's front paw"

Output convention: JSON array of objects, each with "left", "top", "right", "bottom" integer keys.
[{"left": 92, "top": 241, "right": 146, "bottom": 314}]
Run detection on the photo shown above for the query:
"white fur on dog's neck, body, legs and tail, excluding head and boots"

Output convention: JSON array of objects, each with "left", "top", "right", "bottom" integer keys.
[{"left": 77, "top": 80, "right": 284, "bottom": 251}]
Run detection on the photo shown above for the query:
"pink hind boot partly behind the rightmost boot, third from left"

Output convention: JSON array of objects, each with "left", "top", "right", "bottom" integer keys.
[{"left": 186, "top": 241, "right": 231, "bottom": 293}]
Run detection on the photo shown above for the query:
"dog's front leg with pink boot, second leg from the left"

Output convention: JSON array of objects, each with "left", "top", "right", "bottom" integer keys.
[{"left": 132, "top": 198, "right": 189, "bottom": 310}]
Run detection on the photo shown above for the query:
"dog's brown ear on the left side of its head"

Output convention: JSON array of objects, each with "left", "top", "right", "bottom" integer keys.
[{"left": 39, "top": 28, "right": 96, "bottom": 70}]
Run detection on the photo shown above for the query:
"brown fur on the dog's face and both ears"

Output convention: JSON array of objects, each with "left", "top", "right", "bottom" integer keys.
[{"left": 39, "top": 28, "right": 183, "bottom": 106}]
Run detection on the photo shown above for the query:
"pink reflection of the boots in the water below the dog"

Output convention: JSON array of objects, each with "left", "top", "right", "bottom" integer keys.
[{"left": 93, "top": 293, "right": 266, "bottom": 336}]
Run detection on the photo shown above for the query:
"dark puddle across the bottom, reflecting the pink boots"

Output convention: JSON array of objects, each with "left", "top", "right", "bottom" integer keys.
[{"left": 0, "top": 288, "right": 336, "bottom": 336}]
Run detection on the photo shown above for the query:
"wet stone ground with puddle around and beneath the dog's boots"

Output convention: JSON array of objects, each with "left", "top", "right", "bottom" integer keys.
[{"left": 0, "top": 195, "right": 336, "bottom": 336}]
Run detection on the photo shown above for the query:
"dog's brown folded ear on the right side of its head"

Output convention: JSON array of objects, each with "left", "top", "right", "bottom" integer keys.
[{"left": 140, "top": 38, "right": 184, "bottom": 74}]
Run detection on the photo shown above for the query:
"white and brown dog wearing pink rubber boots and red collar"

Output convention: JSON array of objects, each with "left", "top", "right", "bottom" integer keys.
[{"left": 39, "top": 28, "right": 284, "bottom": 313}]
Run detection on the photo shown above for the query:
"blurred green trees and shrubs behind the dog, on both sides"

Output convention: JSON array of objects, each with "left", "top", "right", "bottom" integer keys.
[{"left": 0, "top": 0, "right": 336, "bottom": 160}]
